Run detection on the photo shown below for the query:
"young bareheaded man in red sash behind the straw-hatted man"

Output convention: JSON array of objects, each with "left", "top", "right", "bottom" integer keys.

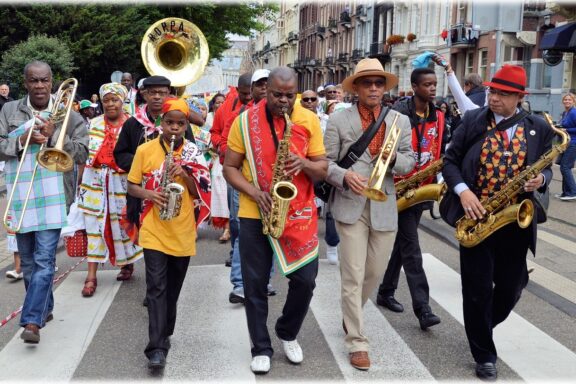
[{"left": 377, "top": 68, "right": 444, "bottom": 330}]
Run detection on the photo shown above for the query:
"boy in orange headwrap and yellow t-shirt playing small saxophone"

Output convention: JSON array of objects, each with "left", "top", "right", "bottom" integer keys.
[{"left": 128, "top": 98, "right": 210, "bottom": 369}]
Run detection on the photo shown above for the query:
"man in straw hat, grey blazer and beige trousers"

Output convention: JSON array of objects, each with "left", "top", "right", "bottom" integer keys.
[{"left": 324, "top": 59, "right": 415, "bottom": 370}]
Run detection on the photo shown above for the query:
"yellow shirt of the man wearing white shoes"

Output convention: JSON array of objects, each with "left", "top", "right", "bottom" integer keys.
[{"left": 228, "top": 104, "right": 326, "bottom": 219}]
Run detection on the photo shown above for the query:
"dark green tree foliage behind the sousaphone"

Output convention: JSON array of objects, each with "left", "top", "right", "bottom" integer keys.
[{"left": 0, "top": 2, "right": 278, "bottom": 94}]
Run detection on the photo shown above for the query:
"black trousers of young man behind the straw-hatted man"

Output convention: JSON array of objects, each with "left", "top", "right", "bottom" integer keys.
[{"left": 378, "top": 204, "right": 430, "bottom": 316}]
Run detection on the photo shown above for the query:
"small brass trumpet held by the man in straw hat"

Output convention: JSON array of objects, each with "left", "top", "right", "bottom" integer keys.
[{"left": 362, "top": 113, "right": 401, "bottom": 201}]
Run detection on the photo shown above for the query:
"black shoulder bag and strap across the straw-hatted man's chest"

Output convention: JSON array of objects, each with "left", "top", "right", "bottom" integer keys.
[{"left": 314, "top": 107, "right": 390, "bottom": 203}]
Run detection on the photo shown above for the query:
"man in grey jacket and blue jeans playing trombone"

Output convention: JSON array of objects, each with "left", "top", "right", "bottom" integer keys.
[{"left": 0, "top": 61, "right": 88, "bottom": 343}]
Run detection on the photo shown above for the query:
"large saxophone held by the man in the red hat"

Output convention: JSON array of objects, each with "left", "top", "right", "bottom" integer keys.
[{"left": 456, "top": 113, "right": 570, "bottom": 248}]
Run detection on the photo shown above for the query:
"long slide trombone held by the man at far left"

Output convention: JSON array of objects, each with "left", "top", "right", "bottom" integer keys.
[{"left": 3, "top": 78, "right": 78, "bottom": 232}]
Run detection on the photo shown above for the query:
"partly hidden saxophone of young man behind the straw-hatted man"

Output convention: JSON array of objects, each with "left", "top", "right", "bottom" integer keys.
[{"left": 395, "top": 158, "right": 447, "bottom": 212}]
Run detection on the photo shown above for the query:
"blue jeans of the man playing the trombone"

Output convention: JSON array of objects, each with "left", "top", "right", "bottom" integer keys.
[{"left": 16, "top": 228, "right": 60, "bottom": 328}]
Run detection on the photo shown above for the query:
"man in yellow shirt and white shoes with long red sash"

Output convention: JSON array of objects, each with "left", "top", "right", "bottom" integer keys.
[{"left": 224, "top": 67, "right": 327, "bottom": 373}]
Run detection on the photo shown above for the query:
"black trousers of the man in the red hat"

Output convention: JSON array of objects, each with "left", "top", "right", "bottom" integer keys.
[{"left": 460, "top": 223, "right": 532, "bottom": 363}]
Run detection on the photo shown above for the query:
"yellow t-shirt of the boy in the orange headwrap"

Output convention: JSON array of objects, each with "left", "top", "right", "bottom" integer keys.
[{"left": 128, "top": 137, "right": 196, "bottom": 256}]
